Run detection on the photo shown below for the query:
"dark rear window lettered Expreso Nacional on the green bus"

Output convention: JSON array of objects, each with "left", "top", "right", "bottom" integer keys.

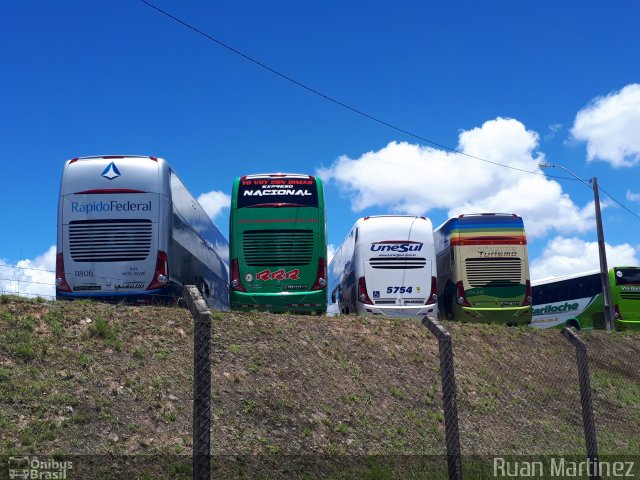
[{"left": 238, "top": 178, "right": 318, "bottom": 208}]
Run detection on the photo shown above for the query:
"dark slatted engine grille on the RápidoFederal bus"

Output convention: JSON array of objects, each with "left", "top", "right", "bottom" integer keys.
[{"left": 69, "top": 220, "right": 153, "bottom": 262}]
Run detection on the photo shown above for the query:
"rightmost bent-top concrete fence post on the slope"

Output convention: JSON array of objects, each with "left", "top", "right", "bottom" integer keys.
[{"left": 560, "top": 327, "right": 600, "bottom": 480}]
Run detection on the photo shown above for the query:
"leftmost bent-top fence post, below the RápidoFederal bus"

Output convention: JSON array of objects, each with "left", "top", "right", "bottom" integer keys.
[{"left": 184, "top": 285, "right": 211, "bottom": 480}]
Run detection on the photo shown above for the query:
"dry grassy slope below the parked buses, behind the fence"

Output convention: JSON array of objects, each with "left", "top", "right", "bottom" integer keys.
[{"left": 0, "top": 296, "right": 640, "bottom": 478}]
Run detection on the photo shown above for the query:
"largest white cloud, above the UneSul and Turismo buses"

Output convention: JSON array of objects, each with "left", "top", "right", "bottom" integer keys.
[{"left": 317, "top": 118, "right": 594, "bottom": 238}]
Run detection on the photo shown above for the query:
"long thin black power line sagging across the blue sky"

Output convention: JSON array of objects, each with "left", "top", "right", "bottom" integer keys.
[{"left": 140, "top": 0, "right": 640, "bottom": 219}]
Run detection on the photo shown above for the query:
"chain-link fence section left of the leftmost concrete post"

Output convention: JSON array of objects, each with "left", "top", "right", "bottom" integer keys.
[{"left": 0, "top": 290, "right": 193, "bottom": 479}]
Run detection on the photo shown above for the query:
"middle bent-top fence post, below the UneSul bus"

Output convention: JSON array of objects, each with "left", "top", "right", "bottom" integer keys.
[{"left": 422, "top": 317, "right": 462, "bottom": 480}]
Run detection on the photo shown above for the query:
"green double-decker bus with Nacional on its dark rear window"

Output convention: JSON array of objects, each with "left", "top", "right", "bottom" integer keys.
[{"left": 229, "top": 173, "right": 327, "bottom": 313}]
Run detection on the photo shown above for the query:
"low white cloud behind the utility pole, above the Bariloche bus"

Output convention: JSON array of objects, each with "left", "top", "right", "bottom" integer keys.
[{"left": 530, "top": 236, "right": 640, "bottom": 280}]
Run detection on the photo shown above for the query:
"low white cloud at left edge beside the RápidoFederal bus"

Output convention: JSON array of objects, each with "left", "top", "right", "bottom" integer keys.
[{"left": 0, "top": 245, "right": 56, "bottom": 299}]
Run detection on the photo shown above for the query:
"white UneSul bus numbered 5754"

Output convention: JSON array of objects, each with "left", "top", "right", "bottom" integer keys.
[{"left": 328, "top": 215, "right": 438, "bottom": 319}]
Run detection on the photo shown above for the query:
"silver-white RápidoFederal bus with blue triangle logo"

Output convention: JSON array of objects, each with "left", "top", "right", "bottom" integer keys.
[{"left": 56, "top": 156, "right": 229, "bottom": 310}]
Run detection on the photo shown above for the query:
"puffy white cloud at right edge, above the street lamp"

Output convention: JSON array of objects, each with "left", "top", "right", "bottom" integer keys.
[{"left": 571, "top": 83, "right": 640, "bottom": 167}]
